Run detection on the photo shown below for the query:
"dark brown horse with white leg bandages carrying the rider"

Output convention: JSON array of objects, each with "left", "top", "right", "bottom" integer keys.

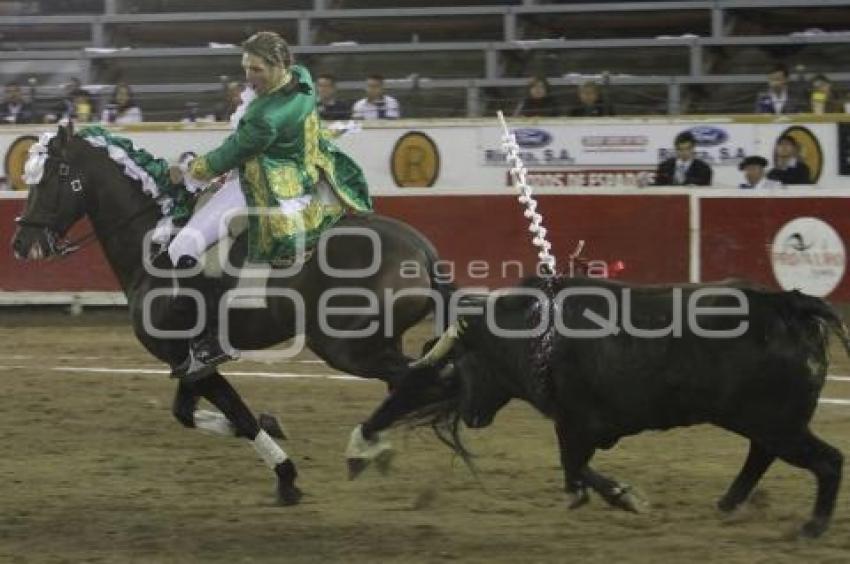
[{"left": 13, "top": 127, "right": 448, "bottom": 504}]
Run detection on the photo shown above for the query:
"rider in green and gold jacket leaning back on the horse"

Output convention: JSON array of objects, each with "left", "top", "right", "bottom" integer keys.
[{"left": 159, "top": 31, "right": 372, "bottom": 379}]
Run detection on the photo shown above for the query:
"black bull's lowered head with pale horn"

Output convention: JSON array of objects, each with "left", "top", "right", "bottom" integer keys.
[{"left": 412, "top": 319, "right": 512, "bottom": 429}]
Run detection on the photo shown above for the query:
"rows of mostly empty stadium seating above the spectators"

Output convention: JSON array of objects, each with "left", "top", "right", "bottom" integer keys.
[{"left": 0, "top": 0, "right": 850, "bottom": 120}]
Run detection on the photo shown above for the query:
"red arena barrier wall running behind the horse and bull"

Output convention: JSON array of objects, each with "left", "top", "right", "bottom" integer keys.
[{"left": 0, "top": 191, "right": 850, "bottom": 302}]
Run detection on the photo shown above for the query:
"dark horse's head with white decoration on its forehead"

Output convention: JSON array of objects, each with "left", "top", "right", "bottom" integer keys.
[{"left": 12, "top": 124, "right": 85, "bottom": 260}]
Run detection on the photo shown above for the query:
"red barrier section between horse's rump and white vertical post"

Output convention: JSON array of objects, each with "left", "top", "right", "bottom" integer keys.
[{"left": 376, "top": 195, "right": 688, "bottom": 287}]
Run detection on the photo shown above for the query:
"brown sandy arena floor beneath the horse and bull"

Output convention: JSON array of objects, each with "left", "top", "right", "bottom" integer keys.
[{"left": 0, "top": 310, "right": 850, "bottom": 564}]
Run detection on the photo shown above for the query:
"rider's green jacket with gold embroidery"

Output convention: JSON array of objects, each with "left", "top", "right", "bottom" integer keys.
[{"left": 191, "top": 65, "right": 372, "bottom": 261}]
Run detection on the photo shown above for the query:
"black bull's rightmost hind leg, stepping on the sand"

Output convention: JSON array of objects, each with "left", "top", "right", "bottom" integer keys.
[{"left": 768, "top": 429, "right": 844, "bottom": 537}]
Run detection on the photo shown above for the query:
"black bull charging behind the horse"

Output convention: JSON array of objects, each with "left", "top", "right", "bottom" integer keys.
[{"left": 380, "top": 279, "right": 850, "bottom": 536}]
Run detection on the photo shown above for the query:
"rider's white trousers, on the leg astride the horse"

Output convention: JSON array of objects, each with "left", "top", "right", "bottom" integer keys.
[{"left": 168, "top": 172, "right": 248, "bottom": 264}]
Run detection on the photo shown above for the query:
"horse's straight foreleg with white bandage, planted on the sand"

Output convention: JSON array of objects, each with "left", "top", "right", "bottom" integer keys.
[{"left": 194, "top": 372, "right": 301, "bottom": 505}]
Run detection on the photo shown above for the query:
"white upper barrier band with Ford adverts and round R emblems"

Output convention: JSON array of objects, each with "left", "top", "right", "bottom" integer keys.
[{"left": 0, "top": 116, "right": 846, "bottom": 195}]
